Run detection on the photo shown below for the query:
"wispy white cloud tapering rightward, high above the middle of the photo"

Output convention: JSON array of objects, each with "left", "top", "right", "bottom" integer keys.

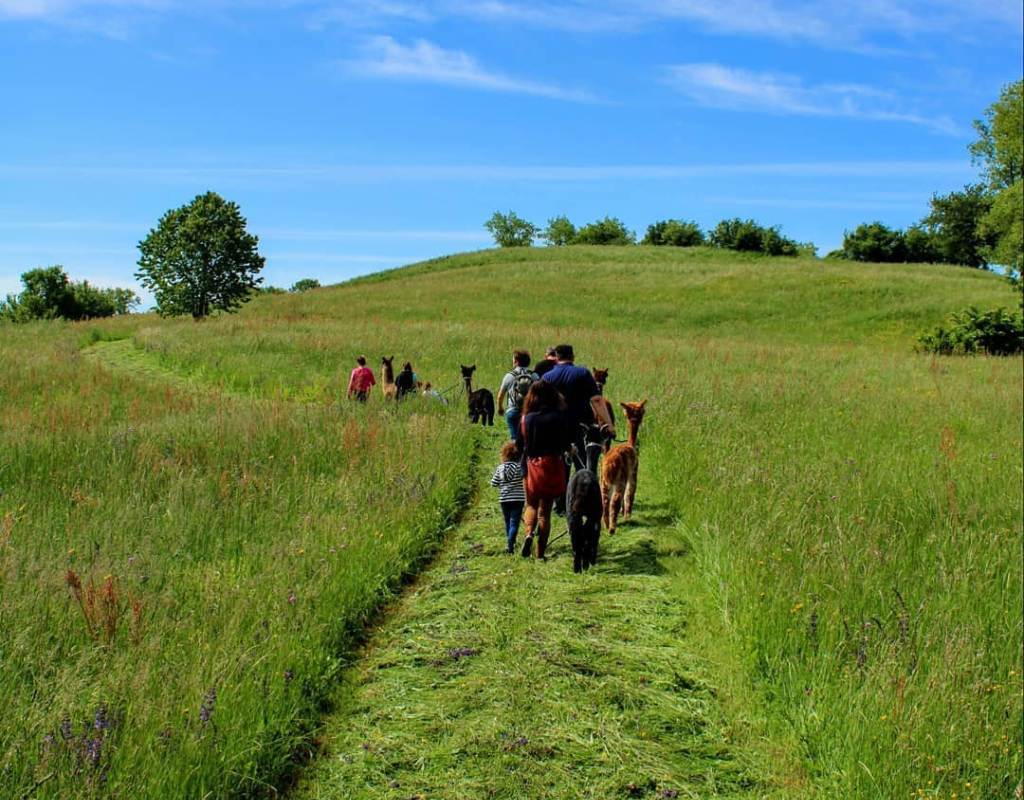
[{"left": 342, "top": 36, "right": 596, "bottom": 102}]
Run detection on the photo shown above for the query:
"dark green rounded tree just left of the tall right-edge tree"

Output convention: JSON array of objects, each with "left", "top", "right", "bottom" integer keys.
[{"left": 922, "top": 183, "right": 995, "bottom": 268}]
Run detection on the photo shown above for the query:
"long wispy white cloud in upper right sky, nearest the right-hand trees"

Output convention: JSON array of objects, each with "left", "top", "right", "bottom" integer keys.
[{"left": 668, "top": 64, "right": 959, "bottom": 134}]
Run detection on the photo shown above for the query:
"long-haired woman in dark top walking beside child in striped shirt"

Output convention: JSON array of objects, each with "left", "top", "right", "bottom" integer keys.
[{"left": 520, "top": 381, "right": 571, "bottom": 559}]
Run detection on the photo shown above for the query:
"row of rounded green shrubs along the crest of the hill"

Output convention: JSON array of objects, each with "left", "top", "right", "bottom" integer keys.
[{"left": 484, "top": 211, "right": 816, "bottom": 256}]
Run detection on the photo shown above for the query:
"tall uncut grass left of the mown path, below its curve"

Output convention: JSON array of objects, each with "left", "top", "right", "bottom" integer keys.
[{"left": 0, "top": 317, "right": 474, "bottom": 798}]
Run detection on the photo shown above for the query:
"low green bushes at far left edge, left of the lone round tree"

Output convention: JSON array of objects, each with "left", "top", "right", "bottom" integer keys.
[{"left": 0, "top": 265, "right": 139, "bottom": 323}]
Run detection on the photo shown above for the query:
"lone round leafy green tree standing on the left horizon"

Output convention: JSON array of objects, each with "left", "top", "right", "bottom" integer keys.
[{"left": 135, "top": 192, "right": 264, "bottom": 320}]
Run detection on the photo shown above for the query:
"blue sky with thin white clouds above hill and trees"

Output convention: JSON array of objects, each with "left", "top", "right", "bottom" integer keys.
[{"left": 0, "top": 0, "right": 1022, "bottom": 293}]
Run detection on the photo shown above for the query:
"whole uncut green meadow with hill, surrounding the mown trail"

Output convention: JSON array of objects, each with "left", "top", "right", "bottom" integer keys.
[{"left": 0, "top": 247, "right": 1024, "bottom": 798}]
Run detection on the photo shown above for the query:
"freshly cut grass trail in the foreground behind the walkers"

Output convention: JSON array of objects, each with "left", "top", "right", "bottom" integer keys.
[{"left": 298, "top": 471, "right": 800, "bottom": 800}]
